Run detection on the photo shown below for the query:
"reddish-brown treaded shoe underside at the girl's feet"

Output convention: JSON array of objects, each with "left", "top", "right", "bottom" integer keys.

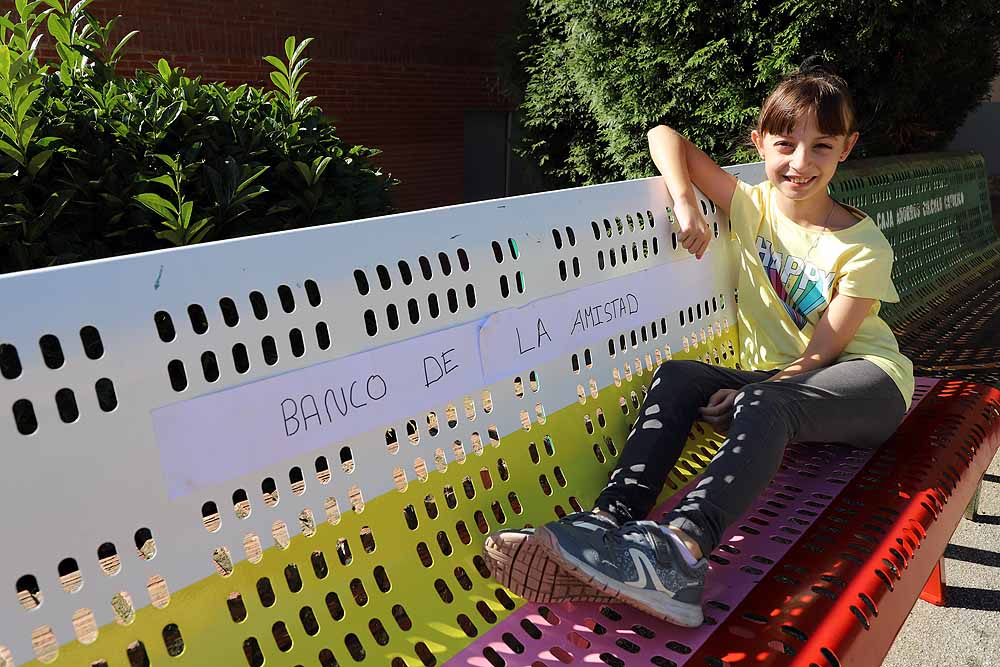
[{"left": 483, "top": 533, "right": 614, "bottom": 604}]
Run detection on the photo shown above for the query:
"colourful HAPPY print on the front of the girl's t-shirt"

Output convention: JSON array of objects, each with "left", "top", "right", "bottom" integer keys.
[{"left": 757, "top": 236, "right": 834, "bottom": 331}]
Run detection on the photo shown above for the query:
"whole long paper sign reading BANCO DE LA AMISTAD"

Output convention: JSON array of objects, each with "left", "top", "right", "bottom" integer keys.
[{"left": 152, "top": 253, "right": 727, "bottom": 498}]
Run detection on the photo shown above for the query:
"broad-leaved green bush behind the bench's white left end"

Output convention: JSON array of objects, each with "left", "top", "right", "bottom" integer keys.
[{"left": 0, "top": 0, "right": 397, "bottom": 273}]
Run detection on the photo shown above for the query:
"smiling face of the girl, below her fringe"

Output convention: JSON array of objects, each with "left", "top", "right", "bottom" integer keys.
[{"left": 751, "top": 115, "right": 858, "bottom": 201}]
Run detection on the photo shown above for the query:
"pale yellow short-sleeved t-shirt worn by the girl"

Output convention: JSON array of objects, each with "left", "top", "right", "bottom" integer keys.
[{"left": 729, "top": 181, "right": 914, "bottom": 407}]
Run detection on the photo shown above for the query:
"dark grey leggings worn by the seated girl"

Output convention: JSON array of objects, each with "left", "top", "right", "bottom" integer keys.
[{"left": 596, "top": 359, "right": 906, "bottom": 555}]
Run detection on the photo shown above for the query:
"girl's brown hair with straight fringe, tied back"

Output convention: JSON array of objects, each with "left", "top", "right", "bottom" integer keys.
[{"left": 757, "top": 57, "right": 855, "bottom": 136}]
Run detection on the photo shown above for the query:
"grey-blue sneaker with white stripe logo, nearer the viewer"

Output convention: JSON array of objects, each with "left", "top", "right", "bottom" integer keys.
[{"left": 535, "top": 521, "right": 708, "bottom": 628}]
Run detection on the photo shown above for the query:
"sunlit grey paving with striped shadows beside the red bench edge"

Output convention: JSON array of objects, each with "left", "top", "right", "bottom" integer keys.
[{"left": 884, "top": 455, "right": 1000, "bottom": 667}]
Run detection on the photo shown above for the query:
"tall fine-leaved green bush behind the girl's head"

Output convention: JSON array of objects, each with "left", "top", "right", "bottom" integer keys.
[{"left": 509, "top": 0, "right": 1000, "bottom": 186}]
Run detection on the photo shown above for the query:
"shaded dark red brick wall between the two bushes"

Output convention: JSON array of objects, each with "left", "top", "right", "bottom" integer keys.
[{"left": 55, "top": 0, "right": 514, "bottom": 211}]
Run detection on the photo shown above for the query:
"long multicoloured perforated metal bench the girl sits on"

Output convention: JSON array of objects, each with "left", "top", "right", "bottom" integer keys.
[{"left": 0, "top": 155, "right": 1000, "bottom": 667}]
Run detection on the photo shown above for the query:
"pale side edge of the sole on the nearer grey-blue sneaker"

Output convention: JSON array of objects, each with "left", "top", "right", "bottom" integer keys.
[{"left": 532, "top": 526, "right": 705, "bottom": 628}]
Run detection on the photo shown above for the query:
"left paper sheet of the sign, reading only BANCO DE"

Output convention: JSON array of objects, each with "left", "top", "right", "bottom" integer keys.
[{"left": 153, "top": 322, "right": 483, "bottom": 498}]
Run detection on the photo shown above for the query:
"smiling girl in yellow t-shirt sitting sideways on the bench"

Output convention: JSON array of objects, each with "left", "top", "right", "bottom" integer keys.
[{"left": 487, "top": 60, "right": 914, "bottom": 626}]
